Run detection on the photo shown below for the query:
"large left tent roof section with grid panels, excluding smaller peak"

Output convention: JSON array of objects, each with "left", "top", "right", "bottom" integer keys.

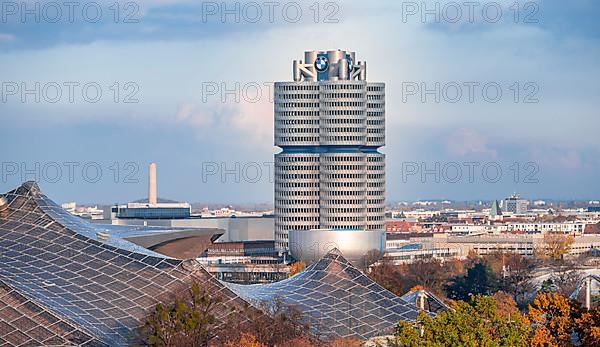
[{"left": 0, "top": 182, "right": 254, "bottom": 346}]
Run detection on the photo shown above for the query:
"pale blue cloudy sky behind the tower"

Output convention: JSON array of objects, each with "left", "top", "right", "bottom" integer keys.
[{"left": 0, "top": 0, "right": 600, "bottom": 203}]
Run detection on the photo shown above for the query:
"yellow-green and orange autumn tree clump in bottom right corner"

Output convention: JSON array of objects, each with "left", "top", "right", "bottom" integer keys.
[{"left": 387, "top": 286, "right": 600, "bottom": 347}]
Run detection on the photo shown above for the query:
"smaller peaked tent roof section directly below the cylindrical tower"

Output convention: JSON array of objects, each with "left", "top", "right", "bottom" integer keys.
[{"left": 223, "top": 249, "right": 418, "bottom": 339}]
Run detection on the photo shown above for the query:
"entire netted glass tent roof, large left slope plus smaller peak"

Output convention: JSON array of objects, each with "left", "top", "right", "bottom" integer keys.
[{"left": 0, "top": 182, "right": 417, "bottom": 346}]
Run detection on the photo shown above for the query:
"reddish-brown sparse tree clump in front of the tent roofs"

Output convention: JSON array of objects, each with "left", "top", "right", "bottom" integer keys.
[{"left": 141, "top": 283, "right": 320, "bottom": 347}]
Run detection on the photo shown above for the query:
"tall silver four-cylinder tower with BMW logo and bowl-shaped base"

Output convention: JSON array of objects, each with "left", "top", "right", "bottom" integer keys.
[{"left": 274, "top": 50, "right": 385, "bottom": 260}]
